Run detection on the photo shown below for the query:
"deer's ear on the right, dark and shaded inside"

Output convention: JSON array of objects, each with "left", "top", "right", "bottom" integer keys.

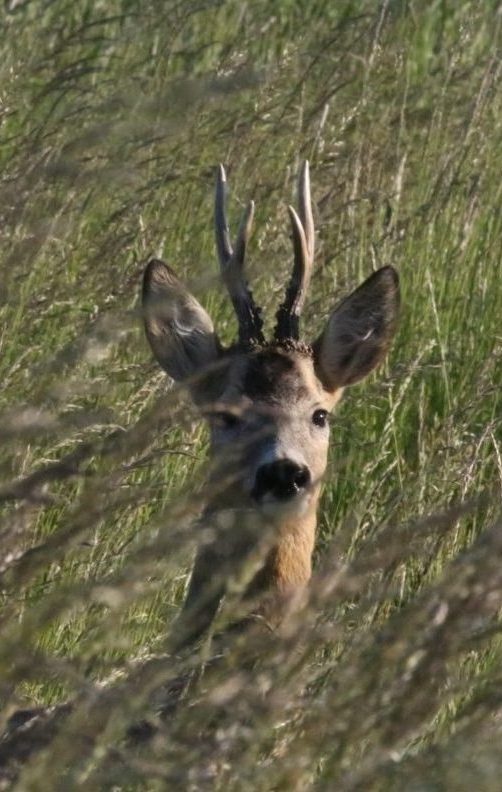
[{"left": 314, "top": 267, "right": 399, "bottom": 392}]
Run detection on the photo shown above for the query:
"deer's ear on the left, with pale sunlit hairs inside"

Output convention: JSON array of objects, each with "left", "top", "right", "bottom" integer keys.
[{"left": 143, "top": 259, "right": 220, "bottom": 396}]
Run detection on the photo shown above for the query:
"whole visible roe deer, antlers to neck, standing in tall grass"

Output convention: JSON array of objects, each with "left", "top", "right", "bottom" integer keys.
[{"left": 143, "top": 162, "right": 399, "bottom": 647}]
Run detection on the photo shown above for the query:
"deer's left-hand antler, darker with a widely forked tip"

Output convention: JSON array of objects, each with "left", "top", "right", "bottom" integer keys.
[{"left": 214, "top": 165, "right": 265, "bottom": 344}]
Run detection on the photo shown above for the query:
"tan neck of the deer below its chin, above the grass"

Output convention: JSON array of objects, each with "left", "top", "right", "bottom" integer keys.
[{"left": 174, "top": 489, "right": 319, "bottom": 648}]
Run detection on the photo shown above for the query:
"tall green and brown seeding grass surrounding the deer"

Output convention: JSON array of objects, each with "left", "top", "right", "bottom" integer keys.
[{"left": 0, "top": 0, "right": 502, "bottom": 790}]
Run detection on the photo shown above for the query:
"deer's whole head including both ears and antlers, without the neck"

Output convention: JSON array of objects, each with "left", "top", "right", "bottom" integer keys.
[{"left": 143, "top": 162, "right": 399, "bottom": 516}]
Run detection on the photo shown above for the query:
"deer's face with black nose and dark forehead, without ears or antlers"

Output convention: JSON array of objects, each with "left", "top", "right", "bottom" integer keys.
[{"left": 208, "top": 345, "right": 340, "bottom": 513}]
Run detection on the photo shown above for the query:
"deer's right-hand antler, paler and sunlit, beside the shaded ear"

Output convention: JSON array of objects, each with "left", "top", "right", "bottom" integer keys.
[{"left": 275, "top": 160, "right": 314, "bottom": 341}]
